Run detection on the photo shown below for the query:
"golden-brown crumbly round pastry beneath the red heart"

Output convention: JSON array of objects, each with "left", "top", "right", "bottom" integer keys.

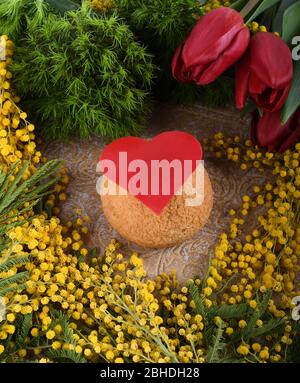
[{"left": 101, "top": 169, "right": 213, "bottom": 248}]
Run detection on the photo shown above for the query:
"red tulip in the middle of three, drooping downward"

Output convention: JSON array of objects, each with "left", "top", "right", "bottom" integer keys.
[{"left": 236, "top": 32, "right": 293, "bottom": 112}]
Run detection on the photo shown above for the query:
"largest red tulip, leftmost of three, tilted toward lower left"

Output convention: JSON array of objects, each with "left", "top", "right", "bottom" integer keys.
[{"left": 172, "top": 7, "right": 250, "bottom": 85}]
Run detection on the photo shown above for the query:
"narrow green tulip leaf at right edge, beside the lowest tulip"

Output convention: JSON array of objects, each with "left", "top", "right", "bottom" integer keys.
[{"left": 281, "top": 60, "right": 300, "bottom": 124}]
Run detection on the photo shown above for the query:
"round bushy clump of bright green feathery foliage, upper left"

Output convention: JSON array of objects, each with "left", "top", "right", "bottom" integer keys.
[{"left": 12, "top": 3, "right": 154, "bottom": 138}]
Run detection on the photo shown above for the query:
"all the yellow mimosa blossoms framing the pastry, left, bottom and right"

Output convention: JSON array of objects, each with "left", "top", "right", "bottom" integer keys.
[{"left": 0, "top": 35, "right": 300, "bottom": 363}]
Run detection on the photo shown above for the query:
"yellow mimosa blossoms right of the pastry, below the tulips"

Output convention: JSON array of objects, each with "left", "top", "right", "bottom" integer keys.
[{"left": 205, "top": 133, "right": 300, "bottom": 361}]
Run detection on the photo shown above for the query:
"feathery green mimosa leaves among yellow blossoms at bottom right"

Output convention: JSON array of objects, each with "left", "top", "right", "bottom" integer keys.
[{"left": 189, "top": 283, "right": 290, "bottom": 363}]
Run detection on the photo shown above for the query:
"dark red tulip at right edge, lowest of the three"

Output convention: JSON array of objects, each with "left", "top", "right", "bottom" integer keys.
[{"left": 251, "top": 108, "right": 300, "bottom": 152}]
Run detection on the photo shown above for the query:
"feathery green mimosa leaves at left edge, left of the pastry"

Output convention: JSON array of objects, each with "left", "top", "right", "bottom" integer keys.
[{"left": 0, "top": 160, "right": 61, "bottom": 297}]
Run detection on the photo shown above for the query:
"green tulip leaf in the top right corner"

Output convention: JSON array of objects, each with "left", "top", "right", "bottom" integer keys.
[{"left": 282, "top": 1, "right": 300, "bottom": 44}]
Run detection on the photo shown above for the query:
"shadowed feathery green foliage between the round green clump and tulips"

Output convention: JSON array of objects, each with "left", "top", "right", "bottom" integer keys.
[{"left": 117, "top": 0, "right": 234, "bottom": 107}]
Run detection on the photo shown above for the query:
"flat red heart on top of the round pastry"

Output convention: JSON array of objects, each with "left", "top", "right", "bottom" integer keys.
[{"left": 99, "top": 131, "right": 202, "bottom": 214}]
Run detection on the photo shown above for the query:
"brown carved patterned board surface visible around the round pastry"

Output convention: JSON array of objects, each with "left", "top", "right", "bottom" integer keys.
[{"left": 42, "top": 105, "right": 264, "bottom": 282}]
